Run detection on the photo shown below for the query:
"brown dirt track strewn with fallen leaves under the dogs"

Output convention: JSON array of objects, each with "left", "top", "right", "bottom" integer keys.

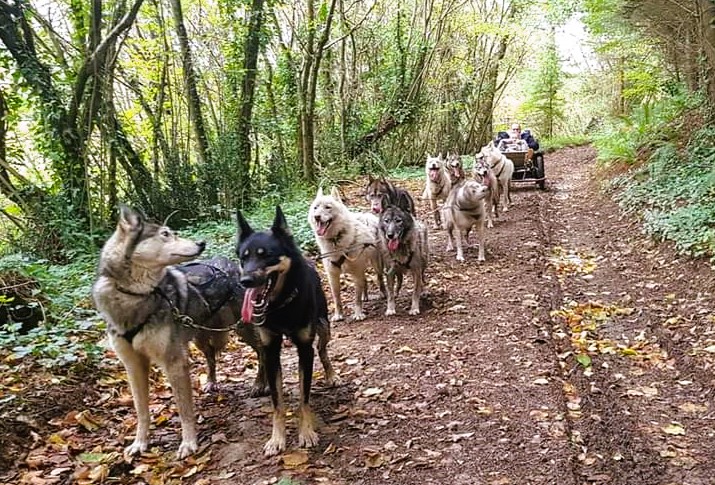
[{"left": 0, "top": 147, "right": 715, "bottom": 485}]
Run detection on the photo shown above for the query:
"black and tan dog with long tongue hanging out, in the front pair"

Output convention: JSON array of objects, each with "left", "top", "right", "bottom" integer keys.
[{"left": 236, "top": 207, "right": 335, "bottom": 456}]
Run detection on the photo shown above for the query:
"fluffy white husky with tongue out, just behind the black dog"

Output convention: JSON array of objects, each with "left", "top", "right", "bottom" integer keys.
[{"left": 308, "top": 188, "right": 385, "bottom": 321}]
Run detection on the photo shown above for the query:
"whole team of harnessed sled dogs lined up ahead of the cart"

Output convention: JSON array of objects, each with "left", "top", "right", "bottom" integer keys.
[{"left": 92, "top": 144, "right": 514, "bottom": 459}]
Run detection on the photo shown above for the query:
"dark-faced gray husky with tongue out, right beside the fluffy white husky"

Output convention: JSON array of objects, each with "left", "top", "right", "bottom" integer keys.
[{"left": 379, "top": 198, "right": 429, "bottom": 316}]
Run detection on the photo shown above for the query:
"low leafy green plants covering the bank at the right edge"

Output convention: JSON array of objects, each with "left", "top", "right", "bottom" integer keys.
[{"left": 611, "top": 125, "right": 715, "bottom": 262}]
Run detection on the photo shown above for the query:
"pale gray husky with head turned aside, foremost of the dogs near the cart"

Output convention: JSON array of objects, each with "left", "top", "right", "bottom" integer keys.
[{"left": 442, "top": 180, "right": 488, "bottom": 261}]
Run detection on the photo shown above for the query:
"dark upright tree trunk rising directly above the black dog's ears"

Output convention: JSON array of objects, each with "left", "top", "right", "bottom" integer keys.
[{"left": 232, "top": 0, "right": 263, "bottom": 207}]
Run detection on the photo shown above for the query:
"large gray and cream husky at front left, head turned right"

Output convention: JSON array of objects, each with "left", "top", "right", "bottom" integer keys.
[{"left": 92, "top": 206, "right": 267, "bottom": 459}]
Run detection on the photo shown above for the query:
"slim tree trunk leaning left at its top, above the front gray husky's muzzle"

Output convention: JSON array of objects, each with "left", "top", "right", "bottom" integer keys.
[{"left": 171, "top": 0, "right": 209, "bottom": 163}]
